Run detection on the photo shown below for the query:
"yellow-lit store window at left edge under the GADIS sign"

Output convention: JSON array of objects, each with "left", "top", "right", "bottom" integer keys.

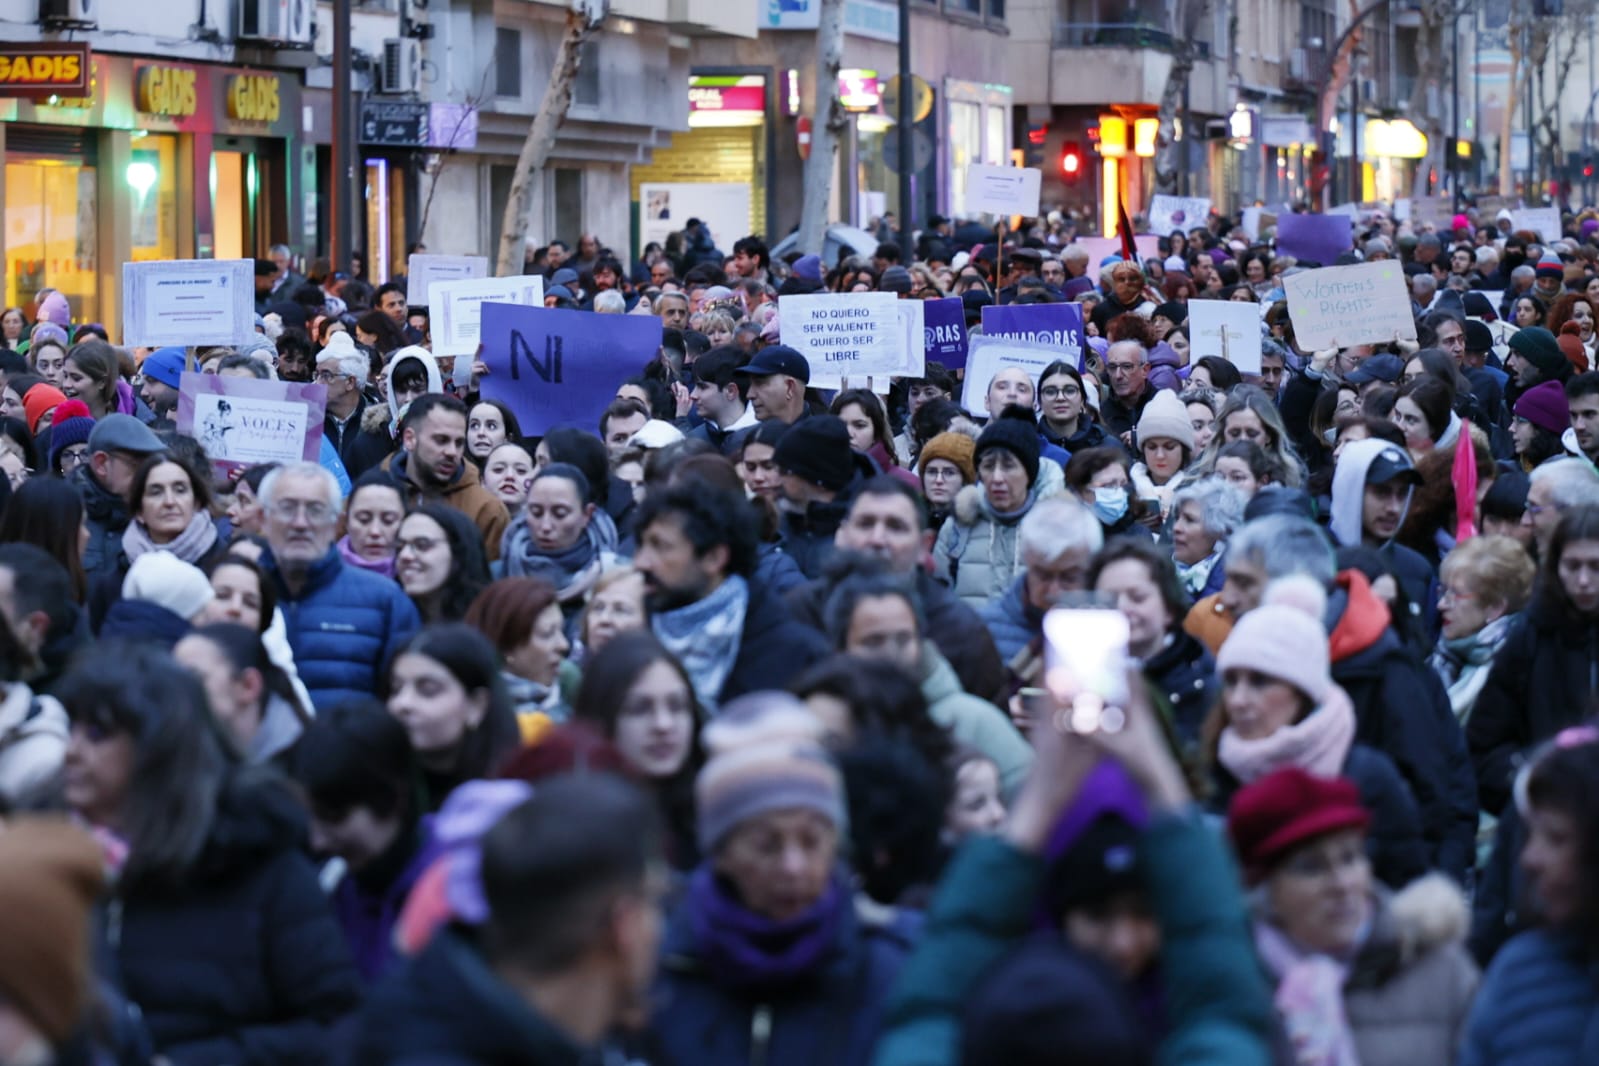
[{"left": 5, "top": 153, "right": 101, "bottom": 321}]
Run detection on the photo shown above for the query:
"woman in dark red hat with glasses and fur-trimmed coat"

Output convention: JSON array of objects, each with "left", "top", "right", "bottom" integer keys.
[{"left": 1228, "top": 767, "right": 1477, "bottom": 1066}]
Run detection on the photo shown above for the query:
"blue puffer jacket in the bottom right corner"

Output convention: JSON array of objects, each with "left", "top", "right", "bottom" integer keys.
[{"left": 1455, "top": 929, "right": 1599, "bottom": 1066}]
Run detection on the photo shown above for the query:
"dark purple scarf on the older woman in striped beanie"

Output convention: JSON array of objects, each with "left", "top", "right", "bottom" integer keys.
[{"left": 684, "top": 863, "right": 851, "bottom": 992}]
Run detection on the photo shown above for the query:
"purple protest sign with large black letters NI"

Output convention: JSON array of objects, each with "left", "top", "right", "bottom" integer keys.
[{"left": 478, "top": 304, "right": 660, "bottom": 436}]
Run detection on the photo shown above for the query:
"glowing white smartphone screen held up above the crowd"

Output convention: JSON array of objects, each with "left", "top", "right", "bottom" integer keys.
[{"left": 1044, "top": 607, "right": 1129, "bottom": 734}]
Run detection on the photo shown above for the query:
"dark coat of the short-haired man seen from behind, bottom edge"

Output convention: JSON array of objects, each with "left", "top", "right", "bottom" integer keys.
[{"left": 349, "top": 930, "right": 584, "bottom": 1066}]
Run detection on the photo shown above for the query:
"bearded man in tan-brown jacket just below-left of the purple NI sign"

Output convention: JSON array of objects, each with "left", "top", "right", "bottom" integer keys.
[{"left": 384, "top": 393, "right": 510, "bottom": 563}]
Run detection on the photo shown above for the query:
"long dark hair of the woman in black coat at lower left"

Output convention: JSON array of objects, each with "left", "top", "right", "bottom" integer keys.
[{"left": 56, "top": 641, "right": 238, "bottom": 884}]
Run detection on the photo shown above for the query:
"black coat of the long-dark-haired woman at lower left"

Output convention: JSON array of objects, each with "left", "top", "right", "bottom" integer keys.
[{"left": 104, "top": 770, "right": 361, "bottom": 1066}]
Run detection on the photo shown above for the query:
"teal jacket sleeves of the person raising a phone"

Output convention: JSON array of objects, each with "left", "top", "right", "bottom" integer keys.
[{"left": 873, "top": 813, "right": 1274, "bottom": 1066}]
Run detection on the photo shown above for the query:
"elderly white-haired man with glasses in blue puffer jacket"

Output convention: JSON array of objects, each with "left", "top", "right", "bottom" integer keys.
[{"left": 257, "top": 462, "right": 422, "bottom": 713}]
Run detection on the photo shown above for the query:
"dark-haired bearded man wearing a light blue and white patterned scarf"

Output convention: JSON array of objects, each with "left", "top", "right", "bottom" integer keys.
[{"left": 633, "top": 478, "right": 828, "bottom": 714}]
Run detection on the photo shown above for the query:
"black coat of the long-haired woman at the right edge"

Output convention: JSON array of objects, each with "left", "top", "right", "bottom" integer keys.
[{"left": 1466, "top": 599, "right": 1599, "bottom": 815}]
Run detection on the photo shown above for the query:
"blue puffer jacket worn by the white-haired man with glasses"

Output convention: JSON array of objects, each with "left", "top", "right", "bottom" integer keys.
[{"left": 261, "top": 548, "right": 422, "bottom": 713}]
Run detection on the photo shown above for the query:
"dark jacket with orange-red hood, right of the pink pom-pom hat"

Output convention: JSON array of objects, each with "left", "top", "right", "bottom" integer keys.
[{"left": 1327, "top": 571, "right": 1477, "bottom": 881}]
